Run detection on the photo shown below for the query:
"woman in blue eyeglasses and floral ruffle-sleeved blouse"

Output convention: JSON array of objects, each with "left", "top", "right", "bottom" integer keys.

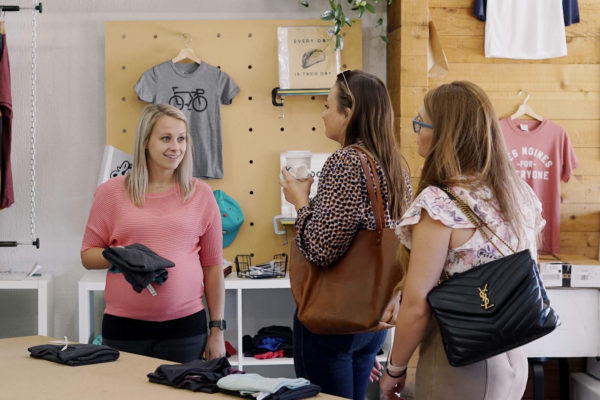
[{"left": 380, "top": 81, "right": 545, "bottom": 400}]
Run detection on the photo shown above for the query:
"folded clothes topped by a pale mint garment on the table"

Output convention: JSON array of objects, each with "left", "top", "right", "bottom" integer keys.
[{"left": 217, "top": 374, "right": 321, "bottom": 400}]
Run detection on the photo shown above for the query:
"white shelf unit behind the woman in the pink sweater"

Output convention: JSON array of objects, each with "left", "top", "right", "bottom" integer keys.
[{"left": 79, "top": 270, "right": 393, "bottom": 370}]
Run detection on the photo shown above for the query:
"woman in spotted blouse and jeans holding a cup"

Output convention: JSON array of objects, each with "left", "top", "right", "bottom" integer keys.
[{"left": 281, "top": 70, "right": 412, "bottom": 400}]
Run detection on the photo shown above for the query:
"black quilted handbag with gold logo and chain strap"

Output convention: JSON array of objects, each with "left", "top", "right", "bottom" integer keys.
[{"left": 427, "top": 186, "right": 560, "bottom": 367}]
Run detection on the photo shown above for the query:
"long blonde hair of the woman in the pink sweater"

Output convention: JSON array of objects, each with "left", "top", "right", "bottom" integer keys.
[{"left": 125, "top": 104, "right": 194, "bottom": 207}]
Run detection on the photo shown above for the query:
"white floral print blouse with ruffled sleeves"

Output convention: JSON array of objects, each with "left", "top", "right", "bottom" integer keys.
[{"left": 396, "top": 182, "right": 546, "bottom": 276}]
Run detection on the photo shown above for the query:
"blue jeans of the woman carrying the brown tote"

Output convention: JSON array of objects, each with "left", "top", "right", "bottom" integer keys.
[{"left": 294, "top": 313, "right": 387, "bottom": 400}]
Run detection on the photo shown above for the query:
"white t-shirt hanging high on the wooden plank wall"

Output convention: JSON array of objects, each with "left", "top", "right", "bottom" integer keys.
[{"left": 485, "top": 0, "right": 567, "bottom": 60}]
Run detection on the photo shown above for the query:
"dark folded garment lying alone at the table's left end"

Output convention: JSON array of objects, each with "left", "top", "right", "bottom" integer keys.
[{"left": 27, "top": 344, "right": 119, "bottom": 366}]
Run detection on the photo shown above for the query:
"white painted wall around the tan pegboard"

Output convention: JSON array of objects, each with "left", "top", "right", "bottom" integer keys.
[{"left": 0, "top": 0, "right": 387, "bottom": 338}]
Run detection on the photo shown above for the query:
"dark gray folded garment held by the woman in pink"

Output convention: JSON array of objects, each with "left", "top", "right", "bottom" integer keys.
[{"left": 102, "top": 243, "right": 175, "bottom": 293}]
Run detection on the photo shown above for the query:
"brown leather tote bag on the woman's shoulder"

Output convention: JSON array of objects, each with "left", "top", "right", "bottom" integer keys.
[{"left": 290, "top": 148, "right": 402, "bottom": 334}]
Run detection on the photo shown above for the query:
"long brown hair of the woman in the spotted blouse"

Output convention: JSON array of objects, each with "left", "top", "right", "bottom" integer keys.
[{"left": 336, "top": 69, "right": 408, "bottom": 219}]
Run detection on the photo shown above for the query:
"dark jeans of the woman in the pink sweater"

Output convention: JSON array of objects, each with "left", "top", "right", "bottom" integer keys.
[{"left": 102, "top": 333, "right": 207, "bottom": 363}]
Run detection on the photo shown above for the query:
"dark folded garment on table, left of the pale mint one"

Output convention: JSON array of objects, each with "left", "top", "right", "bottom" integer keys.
[{"left": 148, "top": 357, "right": 237, "bottom": 393}]
